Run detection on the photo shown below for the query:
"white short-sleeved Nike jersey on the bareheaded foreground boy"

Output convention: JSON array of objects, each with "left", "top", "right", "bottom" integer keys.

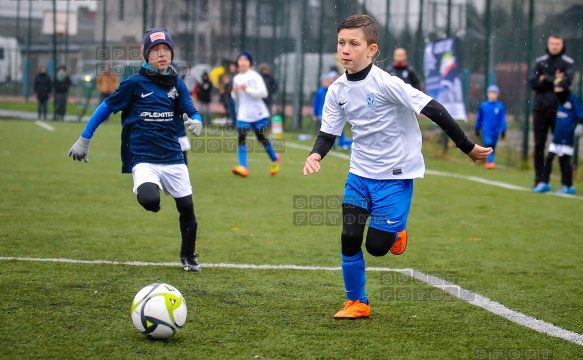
[{"left": 320, "top": 65, "right": 431, "bottom": 180}]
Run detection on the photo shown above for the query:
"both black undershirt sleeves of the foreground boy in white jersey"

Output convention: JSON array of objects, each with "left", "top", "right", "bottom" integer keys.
[{"left": 310, "top": 100, "right": 475, "bottom": 159}]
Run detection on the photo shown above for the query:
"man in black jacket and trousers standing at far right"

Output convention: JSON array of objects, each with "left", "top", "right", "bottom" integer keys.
[{"left": 530, "top": 35, "right": 575, "bottom": 186}]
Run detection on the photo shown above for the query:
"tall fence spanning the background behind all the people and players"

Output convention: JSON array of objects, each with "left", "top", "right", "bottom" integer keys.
[{"left": 0, "top": 0, "right": 583, "bottom": 166}]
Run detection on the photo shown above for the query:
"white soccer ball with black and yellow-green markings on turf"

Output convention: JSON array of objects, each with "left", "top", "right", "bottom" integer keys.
[{"left": 131, "top": 283, "right": 187, "bottom": 339}]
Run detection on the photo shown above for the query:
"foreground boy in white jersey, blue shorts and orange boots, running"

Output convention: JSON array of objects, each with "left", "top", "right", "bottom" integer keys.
[{"left": 304, "top": 15, "right": 492, "bottom": 319}]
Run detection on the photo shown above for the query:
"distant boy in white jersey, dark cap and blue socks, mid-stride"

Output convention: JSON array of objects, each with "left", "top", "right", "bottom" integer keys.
[{"left": 231, "top": 51, "right": 281, "bottom": 177}]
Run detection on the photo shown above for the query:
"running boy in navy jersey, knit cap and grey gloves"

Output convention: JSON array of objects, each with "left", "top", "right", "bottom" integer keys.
[{"left": 69, "top": 28, "right": 202, "bottom": 272}]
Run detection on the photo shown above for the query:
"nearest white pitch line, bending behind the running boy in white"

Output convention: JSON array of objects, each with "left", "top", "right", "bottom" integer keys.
[{"left": 0, "top": 257, "right": 583, "bottom": 346}]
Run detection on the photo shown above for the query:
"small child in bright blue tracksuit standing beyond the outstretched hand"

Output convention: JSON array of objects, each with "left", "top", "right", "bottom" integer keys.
[{"left": 474, "top": 85, "right": 506, "bottom": 169}]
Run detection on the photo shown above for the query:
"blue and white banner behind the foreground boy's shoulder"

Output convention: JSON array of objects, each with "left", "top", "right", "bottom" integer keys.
[{"left": 423, "top": 38, "right": 468, "bottom": 121}]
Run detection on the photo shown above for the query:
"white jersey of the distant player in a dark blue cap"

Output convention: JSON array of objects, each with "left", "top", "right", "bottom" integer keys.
[{"left": 231, "top": 69, "right": 269, "bottom": 122}]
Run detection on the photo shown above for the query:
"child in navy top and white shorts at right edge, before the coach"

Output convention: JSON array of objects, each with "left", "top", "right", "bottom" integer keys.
[{"left": 532, "top": 79, "right": 583, "bottom": 195}]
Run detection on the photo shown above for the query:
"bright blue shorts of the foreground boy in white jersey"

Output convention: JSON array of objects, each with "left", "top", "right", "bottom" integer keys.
[{"left": 342, "top": 173, "right": 413, "bottom": 233}]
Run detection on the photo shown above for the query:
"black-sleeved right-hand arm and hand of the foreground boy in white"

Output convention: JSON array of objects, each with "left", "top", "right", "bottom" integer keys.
[{"left": 421, "top": 100, "right": 492, "bottom": 161}]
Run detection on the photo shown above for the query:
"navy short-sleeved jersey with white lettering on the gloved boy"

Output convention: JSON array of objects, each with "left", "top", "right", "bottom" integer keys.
[{"left": 105, "top": 69, "right": 200, "bottom": 172}]
